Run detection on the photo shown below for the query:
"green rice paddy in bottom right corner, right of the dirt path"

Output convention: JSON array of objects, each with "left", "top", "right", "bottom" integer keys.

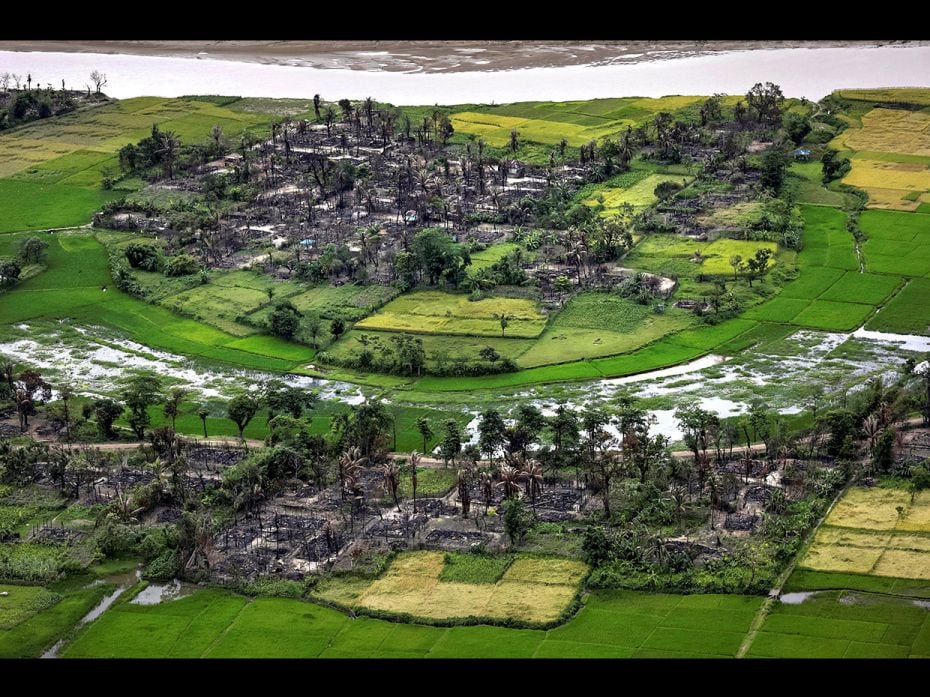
[{"left": 747, "top": 591, "right": 930, "bottom": 658}]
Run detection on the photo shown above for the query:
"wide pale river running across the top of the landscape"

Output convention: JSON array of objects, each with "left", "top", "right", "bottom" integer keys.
[{"left": 0, "top": 44, "right": 930, "bottom": 105}]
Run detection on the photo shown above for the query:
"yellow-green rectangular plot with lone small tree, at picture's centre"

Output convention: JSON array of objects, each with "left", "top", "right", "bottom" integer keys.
[{"left": 355, "top": 291, "right": 546, "bottom": 338}]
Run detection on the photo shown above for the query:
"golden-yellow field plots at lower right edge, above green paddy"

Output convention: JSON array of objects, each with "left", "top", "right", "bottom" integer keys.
[{"left": 800, "top": 487, "right": 930, "bottom": 580}]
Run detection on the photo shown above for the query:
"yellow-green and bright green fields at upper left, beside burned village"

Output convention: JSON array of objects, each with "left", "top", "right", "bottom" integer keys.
[{"left": 0, "top": 97, "right": 271, "bottom": 232}]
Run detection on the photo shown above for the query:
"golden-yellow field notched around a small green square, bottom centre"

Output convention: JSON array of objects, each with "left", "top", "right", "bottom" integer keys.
[{"left": 316, "top": 552, "right": 588, "bottom": 623}]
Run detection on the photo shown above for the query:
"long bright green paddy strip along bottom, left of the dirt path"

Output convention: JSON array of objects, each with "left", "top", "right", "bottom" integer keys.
[{"left": 63, "top": 589, "right": 761, "bottom": 658}]
